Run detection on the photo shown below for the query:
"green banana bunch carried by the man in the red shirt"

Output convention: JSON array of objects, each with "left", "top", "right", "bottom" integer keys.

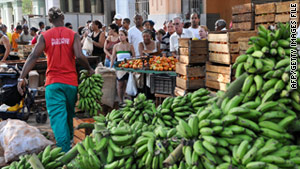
[{"left": 77, "top": 70, "right": 103, "bottom": 116}]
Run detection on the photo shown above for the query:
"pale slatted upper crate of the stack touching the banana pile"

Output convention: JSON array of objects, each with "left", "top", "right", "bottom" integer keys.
[{"left": 208, "top": 31, "right": 257, "bottom": 65}]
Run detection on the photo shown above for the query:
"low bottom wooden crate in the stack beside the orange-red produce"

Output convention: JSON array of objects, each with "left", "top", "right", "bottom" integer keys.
[{"left": 176, "top": 77, "right": 204, "bottom": 90}]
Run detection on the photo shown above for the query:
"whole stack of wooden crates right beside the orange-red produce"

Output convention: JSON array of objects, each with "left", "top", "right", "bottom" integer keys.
[{"left": 174, "top": 38, "right": 208, "bottom": 96}]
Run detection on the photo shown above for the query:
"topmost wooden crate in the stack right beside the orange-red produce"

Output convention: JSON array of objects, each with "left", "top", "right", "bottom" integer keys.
[{"left": 178, "top": 38, "right": 208, "bottom": 64}]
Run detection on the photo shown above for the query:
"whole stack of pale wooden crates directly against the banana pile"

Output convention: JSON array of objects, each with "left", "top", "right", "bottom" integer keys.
[{"left": 205, "top": 31, "right": 256, "bottom": 91}]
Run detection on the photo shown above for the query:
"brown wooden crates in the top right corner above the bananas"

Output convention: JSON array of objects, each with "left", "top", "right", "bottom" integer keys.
[{"left": 255, "top": 1, "right": 300, "bottom": 29}]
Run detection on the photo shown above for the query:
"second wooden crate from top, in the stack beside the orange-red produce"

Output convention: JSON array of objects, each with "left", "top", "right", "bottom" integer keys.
[{"left": 176, "top": 62, "right": 205, "bottom": 77}]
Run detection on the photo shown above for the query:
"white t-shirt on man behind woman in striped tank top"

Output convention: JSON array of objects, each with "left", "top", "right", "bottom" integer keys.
[{"left": 128, "top": 26, "right": 144, "bottom": 57}]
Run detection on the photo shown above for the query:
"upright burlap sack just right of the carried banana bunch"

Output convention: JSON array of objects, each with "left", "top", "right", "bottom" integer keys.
[{"left": 95, "top": 63, "right": 117, "bottom": 107}]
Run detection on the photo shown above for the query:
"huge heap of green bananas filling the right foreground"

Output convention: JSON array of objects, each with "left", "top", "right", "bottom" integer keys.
[{"left": 2, "top": 24, "right": 300, "bottom": 169}]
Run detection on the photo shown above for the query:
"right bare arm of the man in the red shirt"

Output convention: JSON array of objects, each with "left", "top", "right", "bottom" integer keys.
[{"left": 73, "top": 33, "right": 94, "bottom": 74}]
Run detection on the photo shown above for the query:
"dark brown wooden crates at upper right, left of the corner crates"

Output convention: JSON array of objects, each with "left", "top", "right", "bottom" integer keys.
[{"left": 232, "top": 3, "right": 255, "bottom": 31}]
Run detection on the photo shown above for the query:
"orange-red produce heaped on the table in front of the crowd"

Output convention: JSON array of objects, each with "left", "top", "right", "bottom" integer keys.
[{"left": 118, "top": 56, "right": 178, "bottom": 71}]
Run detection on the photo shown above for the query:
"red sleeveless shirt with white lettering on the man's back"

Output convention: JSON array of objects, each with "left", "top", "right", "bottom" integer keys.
[{"left": 42, "top": 27, "right": 78, "bottom": 86}]
